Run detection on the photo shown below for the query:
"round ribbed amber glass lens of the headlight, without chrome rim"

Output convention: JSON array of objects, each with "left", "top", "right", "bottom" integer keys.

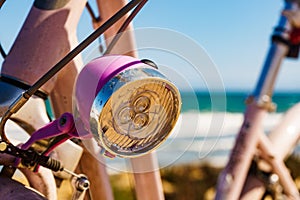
[{"left": 98, "top": 78, "right": 180, "bottom": 156}]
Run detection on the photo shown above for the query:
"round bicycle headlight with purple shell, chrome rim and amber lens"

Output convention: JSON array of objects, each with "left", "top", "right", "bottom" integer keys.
[{"left": 75, "top": 56, "right": 181, "bottom": 157}]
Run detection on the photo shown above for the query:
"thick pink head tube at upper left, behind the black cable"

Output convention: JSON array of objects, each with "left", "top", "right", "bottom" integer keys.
[{"left": 1, "top": 1, "right": 85, "bottom": 93}]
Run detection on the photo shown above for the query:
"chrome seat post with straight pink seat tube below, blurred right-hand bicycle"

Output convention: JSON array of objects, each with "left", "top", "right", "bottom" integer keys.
[{"left": 216, "top": 1, "right": 298, "bottom": 199}]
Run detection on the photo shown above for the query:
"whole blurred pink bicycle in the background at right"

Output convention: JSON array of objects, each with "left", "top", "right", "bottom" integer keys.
[{"left": 216, "top": 0, "right": 300, "bottom": 199}]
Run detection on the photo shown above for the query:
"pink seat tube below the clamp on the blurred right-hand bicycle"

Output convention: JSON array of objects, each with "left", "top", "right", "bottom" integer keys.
[{"left": 216, "top": 102, "right": 267, "bottom": 199}]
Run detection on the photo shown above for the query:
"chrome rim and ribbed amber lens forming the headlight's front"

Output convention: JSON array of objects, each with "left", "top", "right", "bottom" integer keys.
[{"left": 89, "top": 65, "right": 181, "bottom": 157}]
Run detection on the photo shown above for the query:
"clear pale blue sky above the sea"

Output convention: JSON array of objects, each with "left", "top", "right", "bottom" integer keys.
[{"left": 0, "top": 0, "right": 300, "bottom": 91}]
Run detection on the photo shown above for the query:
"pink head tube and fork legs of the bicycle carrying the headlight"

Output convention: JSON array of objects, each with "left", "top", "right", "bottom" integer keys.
[{"left": 2, "top": 0, "right": 163, "bottom": 199}]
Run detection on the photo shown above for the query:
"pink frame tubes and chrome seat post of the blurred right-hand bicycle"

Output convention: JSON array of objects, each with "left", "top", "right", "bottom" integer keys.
[{"left": 216, "top": 1, "right": 299, "bottom": 199}]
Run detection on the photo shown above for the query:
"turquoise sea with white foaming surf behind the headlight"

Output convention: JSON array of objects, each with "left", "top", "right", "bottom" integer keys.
[{"left": 106, "top": 91, "right": 300, "bottom": 173}]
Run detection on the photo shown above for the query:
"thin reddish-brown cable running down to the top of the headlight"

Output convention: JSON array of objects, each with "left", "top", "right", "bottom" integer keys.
[{"left": 104, "top": 0, "right": 148, "bottom": 55}]
